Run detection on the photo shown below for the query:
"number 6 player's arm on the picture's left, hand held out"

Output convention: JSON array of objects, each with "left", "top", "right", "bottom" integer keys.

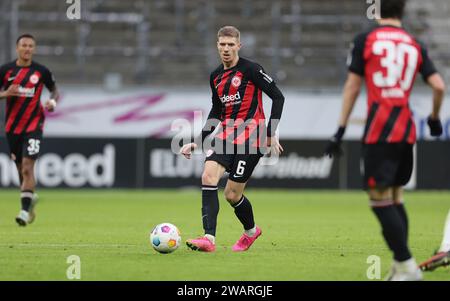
[{"left": 180, "top": 74, "right": 222, "bottom": 159}]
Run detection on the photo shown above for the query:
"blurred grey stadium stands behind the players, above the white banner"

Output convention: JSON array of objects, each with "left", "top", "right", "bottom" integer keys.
[{"left": 0, "top": 0, "right": 450, "bottom": 88}]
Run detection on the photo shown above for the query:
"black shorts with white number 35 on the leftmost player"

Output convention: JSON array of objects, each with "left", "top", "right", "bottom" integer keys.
[{"left": 6, "top": 131, "right": 42, "bottom": 163}]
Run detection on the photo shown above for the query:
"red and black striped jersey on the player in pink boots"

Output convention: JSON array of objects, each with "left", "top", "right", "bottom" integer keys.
[{"left": 202, "top": 58, "right": 284, "bottom": 144}]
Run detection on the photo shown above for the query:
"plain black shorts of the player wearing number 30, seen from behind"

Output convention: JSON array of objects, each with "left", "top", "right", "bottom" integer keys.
[{"left": 362, "top": 143, "right": 414, "bottom": 189}]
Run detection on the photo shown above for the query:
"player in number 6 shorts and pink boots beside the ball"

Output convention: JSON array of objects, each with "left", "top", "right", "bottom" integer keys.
[{"left": 181, "top": 26, "right": 284, "bottom": 252}]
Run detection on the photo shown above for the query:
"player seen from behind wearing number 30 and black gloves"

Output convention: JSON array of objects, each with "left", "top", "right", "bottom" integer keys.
[{"left": 325, "top": 0, "right": 445, "bottom": 281}]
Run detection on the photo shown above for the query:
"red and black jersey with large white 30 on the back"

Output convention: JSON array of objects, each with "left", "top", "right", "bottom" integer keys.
[{"left": 349, "top": 26, "right": 437, "bottom": 144}]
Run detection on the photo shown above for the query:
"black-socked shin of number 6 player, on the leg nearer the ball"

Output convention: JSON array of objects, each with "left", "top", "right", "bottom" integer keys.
[{"left": 202, "top": 185, "right": 219, "bottom": 243}]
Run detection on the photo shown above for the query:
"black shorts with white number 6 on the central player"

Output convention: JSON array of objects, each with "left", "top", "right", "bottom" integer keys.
[{"left": 205, "top": 151, "right": 262, "bottom": 183}]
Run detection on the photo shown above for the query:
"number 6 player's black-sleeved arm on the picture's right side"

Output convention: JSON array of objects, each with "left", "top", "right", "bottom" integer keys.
[{"left": 253, "top": 66, "right": 284, "bottom": 154}]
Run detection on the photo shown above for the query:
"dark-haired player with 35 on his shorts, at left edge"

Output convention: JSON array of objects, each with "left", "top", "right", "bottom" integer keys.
[{"left": 0, "top": 34, "right": 59, "bottom": 226}]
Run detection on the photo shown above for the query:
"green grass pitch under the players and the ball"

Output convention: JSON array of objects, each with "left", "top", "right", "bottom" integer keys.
[{"left": 0, "top": 190, "right": 450, "bottom": 280}]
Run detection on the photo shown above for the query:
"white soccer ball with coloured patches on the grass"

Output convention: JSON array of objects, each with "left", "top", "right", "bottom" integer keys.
[{"left": 150, "top": 223, "right": 181, "bottom": 254}]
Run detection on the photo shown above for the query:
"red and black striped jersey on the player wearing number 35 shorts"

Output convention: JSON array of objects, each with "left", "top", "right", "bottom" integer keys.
[{"left": 0, "top": 61, "right": 55, "bottom": 135}]
